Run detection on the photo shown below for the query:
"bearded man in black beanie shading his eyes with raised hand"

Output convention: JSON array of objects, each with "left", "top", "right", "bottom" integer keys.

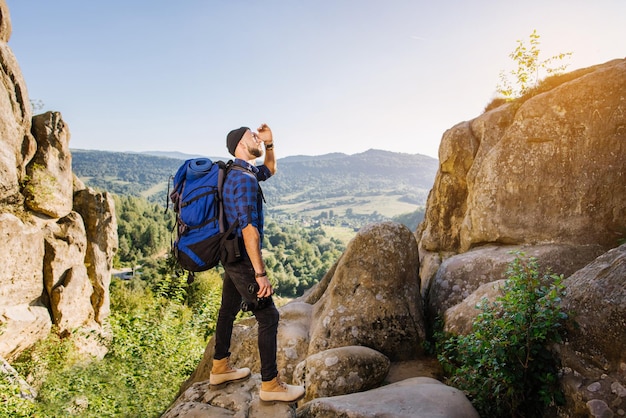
[{"left": 209, "top": 124, "right": 304, "bottom": 402}]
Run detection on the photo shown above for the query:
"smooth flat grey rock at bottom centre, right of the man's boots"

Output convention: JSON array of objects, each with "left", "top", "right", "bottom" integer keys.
[{"left": 297, "top": 377, "right": 478, "bottom": 418}]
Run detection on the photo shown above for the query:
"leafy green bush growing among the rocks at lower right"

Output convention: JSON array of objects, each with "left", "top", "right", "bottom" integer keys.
[{"left": 437, "top": 253, "right": 567, "bottom": 417}]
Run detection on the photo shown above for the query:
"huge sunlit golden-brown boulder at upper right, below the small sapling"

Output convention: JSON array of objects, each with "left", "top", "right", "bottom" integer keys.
[{"left": 420, "top": 59, "right": 626, "bottom": 253}]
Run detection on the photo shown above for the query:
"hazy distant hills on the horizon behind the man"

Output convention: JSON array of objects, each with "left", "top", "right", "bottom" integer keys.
[{"left": 72, "top": 149, "right": 438, "bottom": 227}]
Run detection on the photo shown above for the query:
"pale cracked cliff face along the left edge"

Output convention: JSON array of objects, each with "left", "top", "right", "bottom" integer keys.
[{"left": 0, "top": 0, "right": 117, "bottom": 360}]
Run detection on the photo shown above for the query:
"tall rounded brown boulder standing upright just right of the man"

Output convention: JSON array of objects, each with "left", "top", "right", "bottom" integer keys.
[{"left": 309, "top": 222, "right": 425, "bottom": 361}]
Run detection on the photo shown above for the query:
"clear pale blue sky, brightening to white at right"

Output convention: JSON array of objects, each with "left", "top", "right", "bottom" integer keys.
[{"left": 6, "top": 0, "right": 626, "bottom": 157}]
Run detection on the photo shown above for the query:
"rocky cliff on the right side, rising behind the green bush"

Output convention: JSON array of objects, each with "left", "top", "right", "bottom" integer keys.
[{"left": 416, "top": 59, "right": 626, "bottom": 417}]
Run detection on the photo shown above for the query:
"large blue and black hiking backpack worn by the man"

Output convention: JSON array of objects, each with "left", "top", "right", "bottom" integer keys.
[{"left": 168, "top": 158, "right": 237, "bottom": 273}]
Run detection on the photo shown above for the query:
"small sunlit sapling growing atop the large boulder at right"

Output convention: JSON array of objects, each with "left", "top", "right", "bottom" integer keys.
[{"left": 497, "top": 30, "right": 572, "bottom": 100}]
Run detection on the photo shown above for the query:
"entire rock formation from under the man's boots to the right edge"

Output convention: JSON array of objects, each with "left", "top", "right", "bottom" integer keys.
[{"left": 164, "top": 60, "right": 626, "bottom": 418}]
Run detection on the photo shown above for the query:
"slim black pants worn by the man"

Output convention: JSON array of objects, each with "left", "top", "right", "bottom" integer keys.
[{"left": 214, "top": 258, "right": 279, "bottom": 382}]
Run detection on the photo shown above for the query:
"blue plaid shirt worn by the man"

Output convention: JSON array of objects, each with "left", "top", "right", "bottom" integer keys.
[{"left": 223, "top": 158, "right": 272, "bottom": 247}]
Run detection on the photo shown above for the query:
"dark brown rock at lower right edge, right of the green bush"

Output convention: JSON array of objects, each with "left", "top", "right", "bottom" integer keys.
[{"left": 558, "top": 244, "right": 626, "bottom": 416}]
